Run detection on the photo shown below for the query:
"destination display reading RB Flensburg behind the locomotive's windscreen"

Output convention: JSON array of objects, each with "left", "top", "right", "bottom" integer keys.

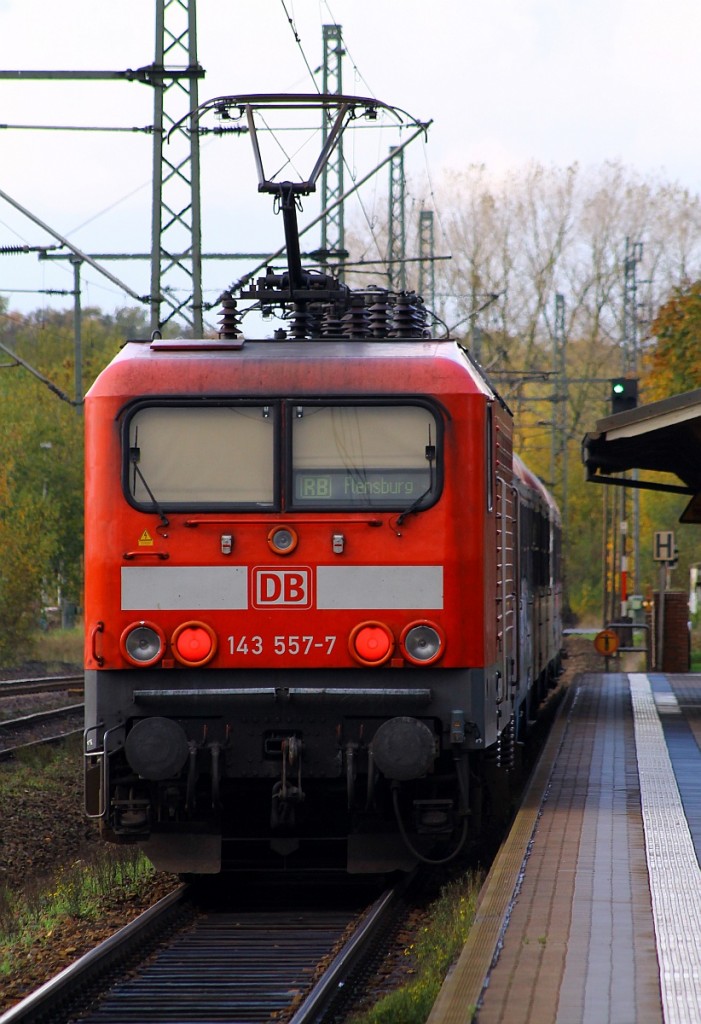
[{"left": 294, "top": 468, "right": 430, "bottom": 508}]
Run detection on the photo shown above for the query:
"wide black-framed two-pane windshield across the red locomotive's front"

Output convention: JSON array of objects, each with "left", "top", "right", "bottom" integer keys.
[{"left": 123, "top": 399, "right": 441, "bottom": 512}]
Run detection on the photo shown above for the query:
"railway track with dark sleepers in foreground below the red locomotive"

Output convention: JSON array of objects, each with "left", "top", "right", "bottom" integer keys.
[{"left": 0, "top": 885, "right": 405, "bottom": 1024}]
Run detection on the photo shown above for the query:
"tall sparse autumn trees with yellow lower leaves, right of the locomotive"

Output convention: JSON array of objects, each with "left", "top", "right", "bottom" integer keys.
[{"left": 365, "top": 162, "right": 701, "bottom": 615}]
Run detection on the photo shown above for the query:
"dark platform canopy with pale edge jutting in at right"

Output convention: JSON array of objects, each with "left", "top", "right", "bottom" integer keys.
[{"left": 582, "top": 388, "right": 701, "bottom": 522}]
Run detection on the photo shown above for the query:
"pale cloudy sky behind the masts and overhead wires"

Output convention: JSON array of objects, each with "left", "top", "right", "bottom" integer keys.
[{"left": 0, "top": 0, "right": 701, "bottom": 312}]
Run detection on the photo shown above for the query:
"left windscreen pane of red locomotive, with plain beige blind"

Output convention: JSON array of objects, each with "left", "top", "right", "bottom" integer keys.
[{"left": 125, "top": 404, "right": 277, "bottom": 509}]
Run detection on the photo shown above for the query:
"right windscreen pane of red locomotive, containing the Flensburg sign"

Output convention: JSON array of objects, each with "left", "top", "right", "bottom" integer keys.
[{"left": 288, "top": 403, "right": 441, "bottom": 511}]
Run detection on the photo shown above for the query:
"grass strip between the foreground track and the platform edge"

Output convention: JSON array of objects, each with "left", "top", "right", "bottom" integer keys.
[{"left": 350, "top": 873, "right": 482, "bottom": 1024}]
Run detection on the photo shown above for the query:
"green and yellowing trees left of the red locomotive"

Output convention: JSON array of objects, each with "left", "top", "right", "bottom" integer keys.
[{"left": 0, "top": 309, "right": 137, "bottom": 666}]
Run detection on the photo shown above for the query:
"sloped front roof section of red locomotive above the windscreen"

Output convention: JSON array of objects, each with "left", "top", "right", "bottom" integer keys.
[{"left": 87, "top": 338, "right": 500, "bottom": 401}]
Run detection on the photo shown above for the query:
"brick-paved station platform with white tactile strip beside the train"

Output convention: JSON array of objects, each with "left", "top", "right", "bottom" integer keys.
[{"left": 429, "top": 673, "right": 701, "bottom": 1024}]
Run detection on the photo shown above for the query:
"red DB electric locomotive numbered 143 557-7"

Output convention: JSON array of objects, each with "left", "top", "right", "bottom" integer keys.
[{"left": 85, "top": 97, "right": 561, "bottom": 873}]
